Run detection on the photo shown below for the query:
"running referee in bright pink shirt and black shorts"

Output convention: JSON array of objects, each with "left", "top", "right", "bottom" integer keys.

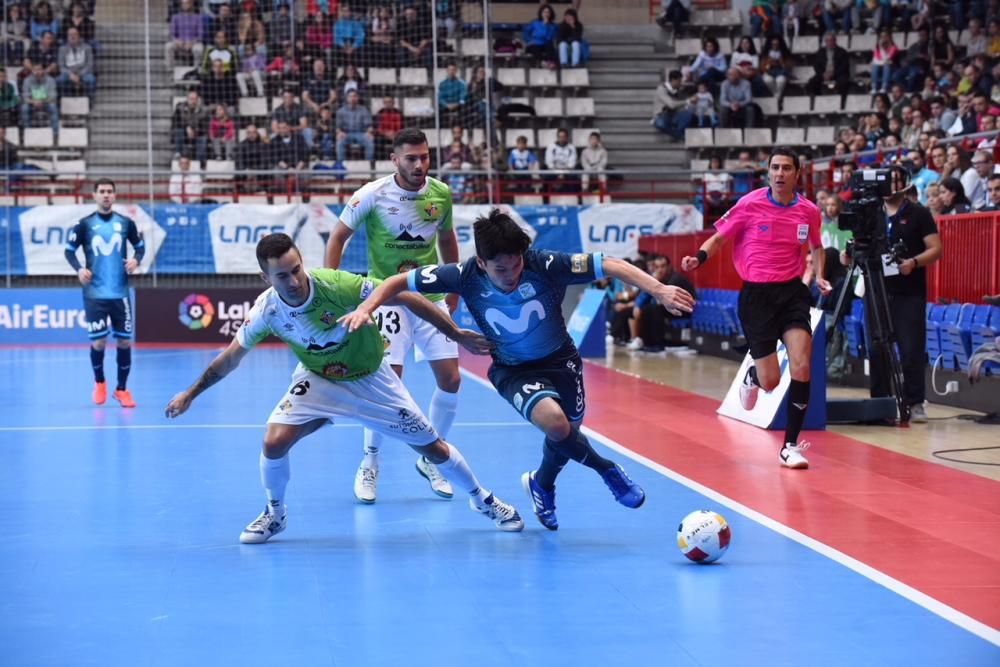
[{"left": 681, "top": 148, "right": 830, "bottom": 468}]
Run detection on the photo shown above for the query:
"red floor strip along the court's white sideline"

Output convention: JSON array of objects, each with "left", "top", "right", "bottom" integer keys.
[{"left": 462, "top": 355, "right": 1000, "bottom": 628}]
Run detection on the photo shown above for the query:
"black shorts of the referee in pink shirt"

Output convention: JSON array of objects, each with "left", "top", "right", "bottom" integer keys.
[{"left": 737, "top": 278, "right": 812, "bottom": 359}]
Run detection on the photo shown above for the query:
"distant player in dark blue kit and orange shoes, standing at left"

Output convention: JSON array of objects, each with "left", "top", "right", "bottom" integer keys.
[{"left": 66, "top": 178, "right": 146, "bottom": 408}]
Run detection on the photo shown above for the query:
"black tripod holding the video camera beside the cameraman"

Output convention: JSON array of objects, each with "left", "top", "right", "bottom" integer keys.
[{"left": 831, "top": 240, "right": 910, "bottom": 425}]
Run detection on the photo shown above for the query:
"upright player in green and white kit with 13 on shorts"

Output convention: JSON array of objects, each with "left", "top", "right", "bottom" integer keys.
[{"left": 326, "top": 129, "right": 461, "bottom": 503}]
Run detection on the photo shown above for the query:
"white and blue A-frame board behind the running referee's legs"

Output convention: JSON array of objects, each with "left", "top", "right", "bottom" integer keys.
[{"left": 717, "top": 308, "right": 826, "bottom": 430}]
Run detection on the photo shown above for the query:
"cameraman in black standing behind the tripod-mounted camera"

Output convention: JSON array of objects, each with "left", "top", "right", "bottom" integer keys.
[{"left": 841, "top": 165, "right": 941, "bottom": 424}]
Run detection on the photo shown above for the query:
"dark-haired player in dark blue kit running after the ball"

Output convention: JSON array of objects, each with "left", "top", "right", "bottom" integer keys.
[{"left": 341, "top": 209, "right": 694, "bottom": 530}]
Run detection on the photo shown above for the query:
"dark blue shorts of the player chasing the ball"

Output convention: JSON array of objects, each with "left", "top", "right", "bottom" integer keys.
[{"left": 489, "top": 347, "right": 587, "bottom": 422}]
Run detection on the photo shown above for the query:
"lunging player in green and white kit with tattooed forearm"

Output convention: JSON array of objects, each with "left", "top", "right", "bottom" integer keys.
[{"left": 166, "top": 234, "right": 524, "bottom": 544}]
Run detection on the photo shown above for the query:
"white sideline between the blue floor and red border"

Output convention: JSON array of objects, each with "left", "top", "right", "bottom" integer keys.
[{"left": 461, "top": 368, "right": 1000, "bottom": 646}]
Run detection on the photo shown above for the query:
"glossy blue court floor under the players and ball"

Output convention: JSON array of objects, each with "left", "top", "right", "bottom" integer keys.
[{"left": 0, "top": 348, "right": 1000, "bottom": 667}]
